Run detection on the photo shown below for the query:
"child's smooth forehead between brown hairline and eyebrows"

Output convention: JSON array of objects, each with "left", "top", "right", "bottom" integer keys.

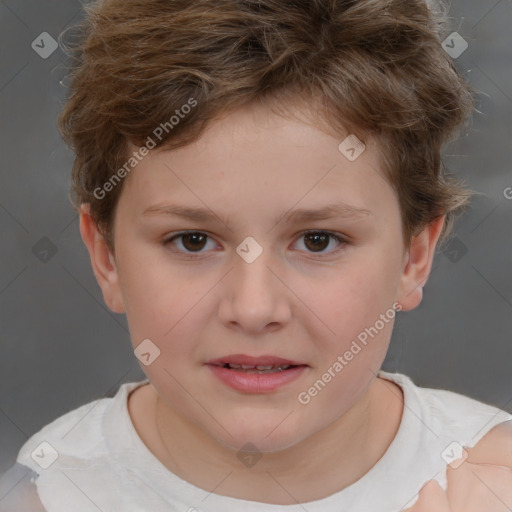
[{"left": 120, "top": 101, "right": 394, "bottom": 225}]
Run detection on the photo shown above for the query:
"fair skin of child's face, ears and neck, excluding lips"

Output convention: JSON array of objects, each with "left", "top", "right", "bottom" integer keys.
[{"left": 80, "top": 100, "right": 443, "bottom": 505}]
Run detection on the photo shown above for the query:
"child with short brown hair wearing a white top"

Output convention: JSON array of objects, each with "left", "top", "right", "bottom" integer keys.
[{"left": 0, "top": 0, "right": 512, "bottom": 512}]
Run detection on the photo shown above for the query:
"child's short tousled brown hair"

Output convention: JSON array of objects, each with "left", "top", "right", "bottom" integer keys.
[{"left": 58, "top": 0, "right": 475, "bottom": 248}]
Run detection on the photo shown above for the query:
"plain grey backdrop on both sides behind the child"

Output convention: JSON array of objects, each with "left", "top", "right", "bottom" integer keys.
[{"left": 0, "top": 0, "right": 512, "bottom": 473}]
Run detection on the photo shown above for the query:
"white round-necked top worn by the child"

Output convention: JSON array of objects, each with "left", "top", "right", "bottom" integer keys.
[{"left": 0, "top": 370, "right": 512, "bottom": 512}]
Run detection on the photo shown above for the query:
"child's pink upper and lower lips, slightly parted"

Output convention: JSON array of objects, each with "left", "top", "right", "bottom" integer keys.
[{"left": 206, "top": 354, "right": 309, "bottom": 394}]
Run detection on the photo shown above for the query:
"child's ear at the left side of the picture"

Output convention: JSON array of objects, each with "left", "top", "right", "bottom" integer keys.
[{"left": 80, "top": 205, "right": 125, "bottom": 313}]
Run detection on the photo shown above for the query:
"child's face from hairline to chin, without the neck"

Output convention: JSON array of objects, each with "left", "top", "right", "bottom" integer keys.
[{"left": 84, "top": 100, "right": 435, "bottom": 451}]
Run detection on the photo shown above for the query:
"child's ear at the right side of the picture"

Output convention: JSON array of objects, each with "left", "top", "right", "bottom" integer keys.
[{"left": 397, "top": 215, "right": 445, "bottom": 311}]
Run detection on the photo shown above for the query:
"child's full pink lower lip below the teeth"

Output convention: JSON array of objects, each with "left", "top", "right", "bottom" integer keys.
[{"left": 207, "top": 364, "right": 307, "bottom": 393}]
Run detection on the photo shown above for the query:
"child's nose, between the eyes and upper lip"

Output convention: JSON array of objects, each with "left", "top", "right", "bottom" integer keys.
[{"left": 219, "top": 242, "right": 291, "bottom": 335}]
